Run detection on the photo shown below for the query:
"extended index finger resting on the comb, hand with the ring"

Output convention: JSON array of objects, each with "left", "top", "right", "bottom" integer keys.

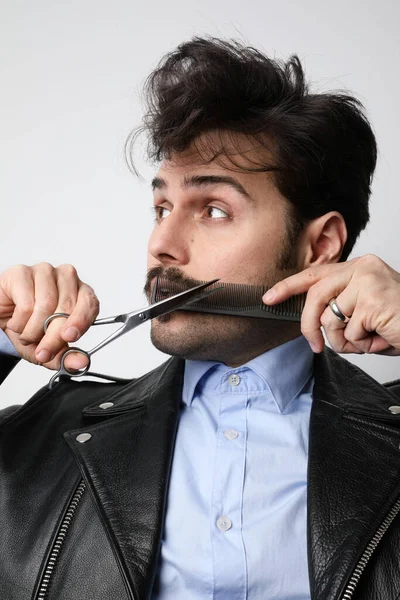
[{"left": 262, "top": 263, "right": 348, "bottom": 304}]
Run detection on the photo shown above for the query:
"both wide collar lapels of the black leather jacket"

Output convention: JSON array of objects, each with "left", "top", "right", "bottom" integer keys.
[{"left": 65, "top": 348, "right": 400, "bottom": 600}]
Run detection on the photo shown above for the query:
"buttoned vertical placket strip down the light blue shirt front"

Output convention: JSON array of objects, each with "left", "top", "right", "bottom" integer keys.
[{"left": 211, "top": 372, "right": 248, "bottom": 600}]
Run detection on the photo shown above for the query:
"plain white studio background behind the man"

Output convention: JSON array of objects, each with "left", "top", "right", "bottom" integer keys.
[{"left": 0, "top": 0, "right": 400, "bottom": 406}]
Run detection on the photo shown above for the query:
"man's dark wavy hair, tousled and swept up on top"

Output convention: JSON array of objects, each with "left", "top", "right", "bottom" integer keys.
[{"left": 126, "top": 37, "right": 377, "bottom": 261}]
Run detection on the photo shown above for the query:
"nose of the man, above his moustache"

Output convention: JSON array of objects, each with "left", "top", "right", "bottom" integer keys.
[{"left": 148, "top": 209, "right": 189, "bottom": 266}]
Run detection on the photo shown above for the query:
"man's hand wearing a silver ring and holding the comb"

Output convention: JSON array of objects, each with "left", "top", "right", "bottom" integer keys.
[{"left": 263, "top": 254, "right": 400, "bottom": 356}]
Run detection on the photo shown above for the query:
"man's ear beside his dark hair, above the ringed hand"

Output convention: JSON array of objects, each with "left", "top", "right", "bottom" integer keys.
[{"left": 299, "top": 211, "right": 347, "bottom": 269}]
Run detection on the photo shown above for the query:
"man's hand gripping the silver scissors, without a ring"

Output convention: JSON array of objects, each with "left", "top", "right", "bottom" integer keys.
[{"left": 0, "top": 263, "right": 99, "bottom": 369}]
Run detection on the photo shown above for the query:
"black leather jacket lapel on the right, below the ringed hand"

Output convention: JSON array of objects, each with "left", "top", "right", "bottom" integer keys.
[{"left": 307, "top": 348, "right": 400, "bottom": 600}]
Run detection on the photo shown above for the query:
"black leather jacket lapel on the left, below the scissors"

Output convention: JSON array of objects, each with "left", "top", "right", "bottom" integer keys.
[{"left": 65, "top": 359, "right": 184, "bottom": 600}]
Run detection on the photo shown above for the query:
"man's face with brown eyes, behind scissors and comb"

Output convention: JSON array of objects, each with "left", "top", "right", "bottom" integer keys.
[{"left": 147, "top": 142, "right": 299, "bottom": 365}]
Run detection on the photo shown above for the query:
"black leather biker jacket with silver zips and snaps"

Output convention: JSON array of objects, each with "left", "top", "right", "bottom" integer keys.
[{"left": 0, "top": 348, "right": 400, "bottom": 600}]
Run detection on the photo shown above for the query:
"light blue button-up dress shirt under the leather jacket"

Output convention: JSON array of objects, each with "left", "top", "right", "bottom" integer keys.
[{"left": 0, "top": 331, "right": 314, "bottom": 600}]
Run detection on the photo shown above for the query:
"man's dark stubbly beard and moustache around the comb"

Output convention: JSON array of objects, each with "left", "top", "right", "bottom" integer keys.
[{"left": 144, "top": 234, "right": 300, "bottom": 367}]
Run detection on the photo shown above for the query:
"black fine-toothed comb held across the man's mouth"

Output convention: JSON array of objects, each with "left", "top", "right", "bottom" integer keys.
[{"left": 151, "top": 277, "right": 306, "bottom": 321}]
